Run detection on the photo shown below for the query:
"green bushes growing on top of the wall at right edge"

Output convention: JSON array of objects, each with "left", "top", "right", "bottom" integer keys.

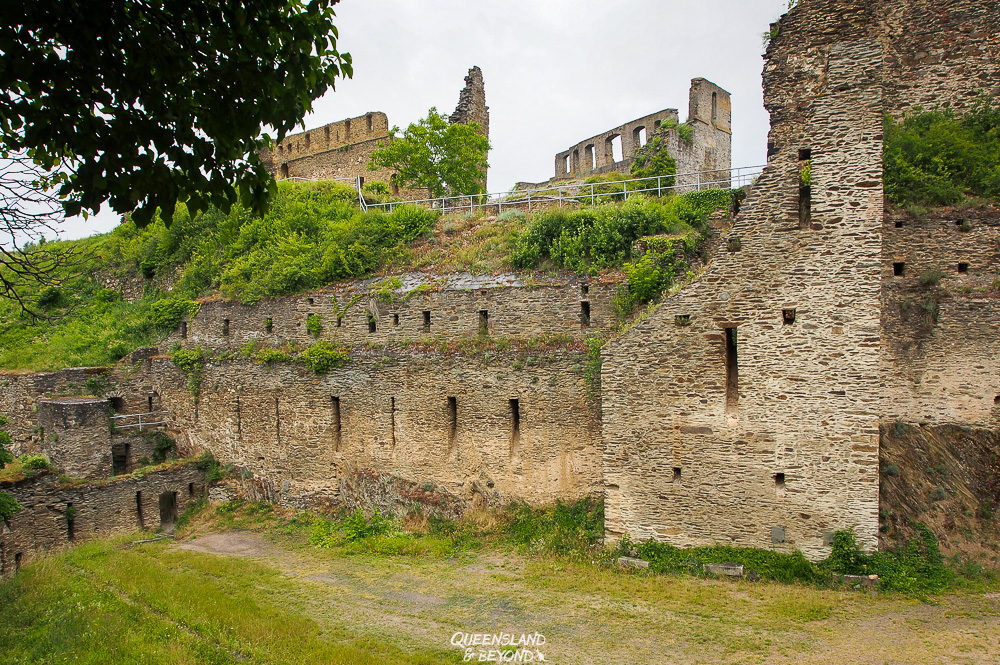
[{"left": 883, "top": 97, "right": 1000, "bottom": 205}]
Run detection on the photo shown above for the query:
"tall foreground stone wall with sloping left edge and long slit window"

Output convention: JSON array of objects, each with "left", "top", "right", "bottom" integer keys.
[{"left": 602, "top": 18, "right": 882, "bottom": 558}]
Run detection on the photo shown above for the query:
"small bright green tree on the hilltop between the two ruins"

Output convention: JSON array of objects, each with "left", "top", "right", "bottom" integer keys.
[{"left": 368, "top": 108, "right": 490, "bottom": 197}]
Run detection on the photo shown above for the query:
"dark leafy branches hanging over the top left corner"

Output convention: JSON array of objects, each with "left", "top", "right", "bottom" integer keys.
[{"left": 0, "top": 0, "right": 352, "bottom": 225}]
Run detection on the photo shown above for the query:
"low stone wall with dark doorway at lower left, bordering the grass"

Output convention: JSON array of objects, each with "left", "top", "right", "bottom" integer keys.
[{"left": 0, "top": 466, "right": 206, "bottom": 576}]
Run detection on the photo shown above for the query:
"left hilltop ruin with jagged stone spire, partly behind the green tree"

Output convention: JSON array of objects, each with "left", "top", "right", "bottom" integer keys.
[{"left": 260, "top": 67, "right": 490, "bottom": 198}]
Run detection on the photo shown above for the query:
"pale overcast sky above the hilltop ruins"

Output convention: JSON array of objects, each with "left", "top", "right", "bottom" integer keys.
[{"left": 56, "top": 0, "right": 787, "bottom": 238}]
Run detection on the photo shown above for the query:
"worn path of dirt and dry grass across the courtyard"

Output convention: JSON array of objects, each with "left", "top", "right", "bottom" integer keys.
[{"left": 177, "top": 531, "right": 1000, "bottom": 665}]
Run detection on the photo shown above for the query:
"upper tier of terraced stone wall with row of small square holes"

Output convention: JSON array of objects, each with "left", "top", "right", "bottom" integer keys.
[{"left": 166, "top": 275, "right": 616, "bottom": 348}]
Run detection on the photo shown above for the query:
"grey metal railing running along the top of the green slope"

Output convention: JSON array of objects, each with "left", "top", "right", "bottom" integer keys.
[{"left": 355, "top": 165, "right": 764, "bottom": 215}]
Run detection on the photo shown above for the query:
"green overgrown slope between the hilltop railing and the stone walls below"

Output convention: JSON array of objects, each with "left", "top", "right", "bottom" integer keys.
[{"left": 0, "top": 183, "right": 728, "bottom": 371}]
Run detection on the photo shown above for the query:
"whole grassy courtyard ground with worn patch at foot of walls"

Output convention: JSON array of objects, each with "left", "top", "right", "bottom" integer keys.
[{"left": 0, "top": 504, "right": 1000, "bottom": 664}]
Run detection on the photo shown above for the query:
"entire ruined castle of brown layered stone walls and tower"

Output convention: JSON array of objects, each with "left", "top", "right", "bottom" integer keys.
[{"left": 0, "top": 0, "right": 1000, "bottom": 565}]
